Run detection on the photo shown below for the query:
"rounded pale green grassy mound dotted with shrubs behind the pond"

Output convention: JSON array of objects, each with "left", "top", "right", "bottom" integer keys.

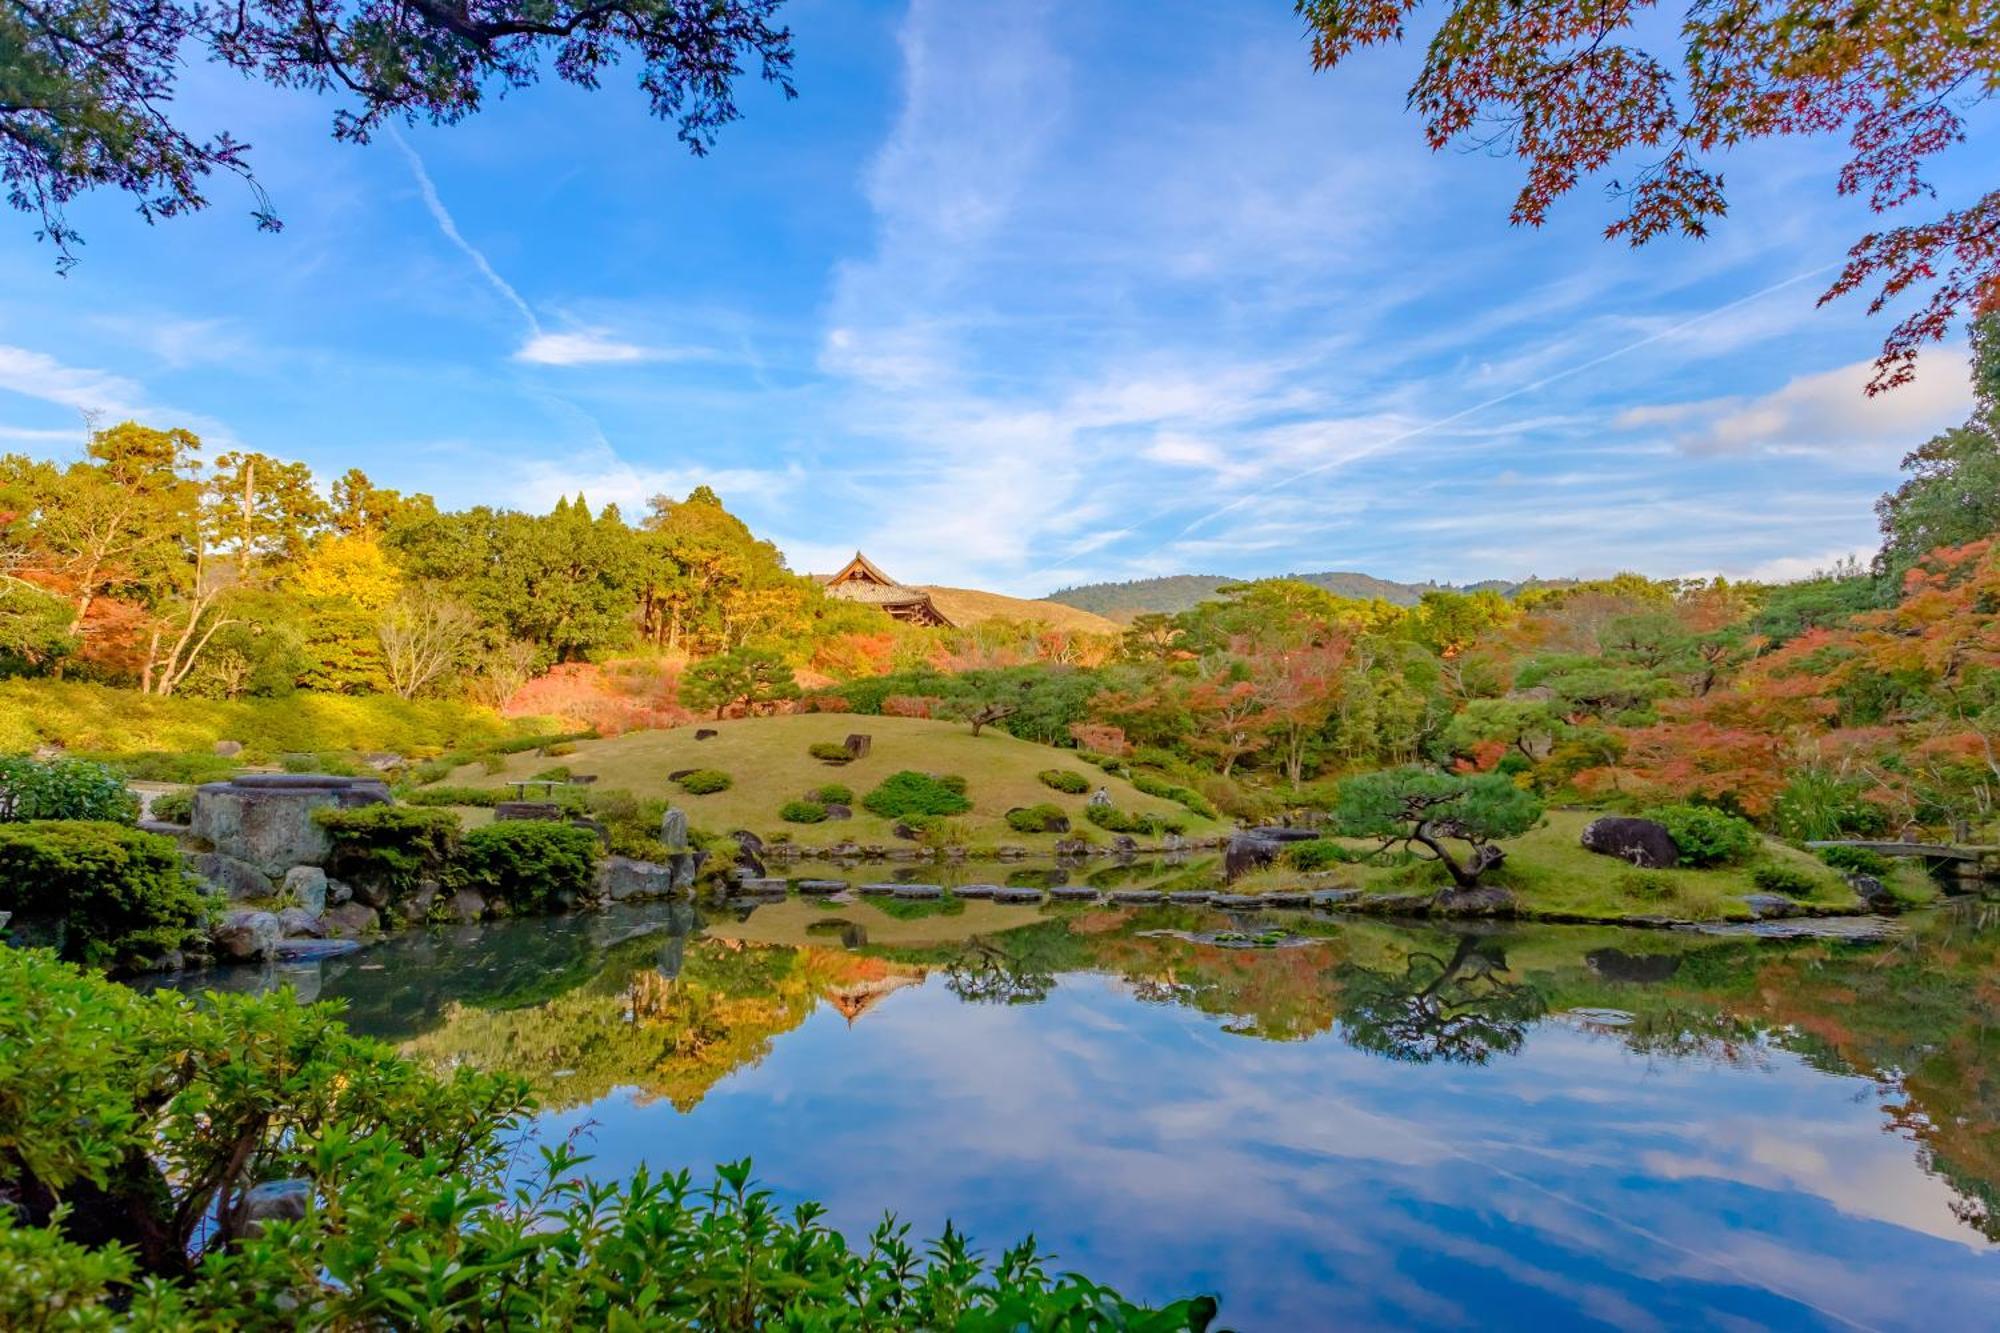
[{"left": 446, "top": 713, "right": 1228, "bottom": 849}]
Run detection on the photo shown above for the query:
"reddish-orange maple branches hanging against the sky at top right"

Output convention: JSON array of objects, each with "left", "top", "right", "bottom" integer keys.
[{"left": 1298, "top": 0, "right": 2000, "bottom": 392}]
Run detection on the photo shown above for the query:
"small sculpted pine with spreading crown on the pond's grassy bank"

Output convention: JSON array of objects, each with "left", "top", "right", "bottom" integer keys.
[{"left": 1334, "top": 765, "right": 1542, "bottom": 889}]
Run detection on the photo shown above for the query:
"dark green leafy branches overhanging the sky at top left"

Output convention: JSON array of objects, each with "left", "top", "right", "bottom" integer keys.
[{"left": 0, "top": 0, "right": 792, "bottom": 268}]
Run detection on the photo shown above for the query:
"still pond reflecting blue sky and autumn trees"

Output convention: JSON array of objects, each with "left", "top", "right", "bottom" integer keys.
[{"left": 160, "top": 901, "right": 2000, "bottom": 1329}]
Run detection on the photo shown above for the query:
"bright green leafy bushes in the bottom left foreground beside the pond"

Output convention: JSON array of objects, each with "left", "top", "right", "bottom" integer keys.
[{"left": 0, "top": 951, "right": 1216, "bottom": 1333}]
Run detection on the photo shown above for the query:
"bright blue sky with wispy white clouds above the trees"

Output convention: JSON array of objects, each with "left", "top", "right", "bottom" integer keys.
[{"left": 0, "top": 0, "right": 2000, "bottom": 596}]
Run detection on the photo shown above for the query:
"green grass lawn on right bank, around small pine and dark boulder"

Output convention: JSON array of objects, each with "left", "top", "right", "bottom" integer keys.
[{"left": 1240, "top": 811, "right": 1936, "bottom": 921}]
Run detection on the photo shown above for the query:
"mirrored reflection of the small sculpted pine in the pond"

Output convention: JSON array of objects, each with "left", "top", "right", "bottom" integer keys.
[{"left": 1338, "top": 935, "right": 1548, "bottom": 1065}]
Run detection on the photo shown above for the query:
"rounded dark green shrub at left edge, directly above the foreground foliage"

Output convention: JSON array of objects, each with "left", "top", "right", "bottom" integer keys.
[{"left": 0, "top": 821, "right": 208, "bottom": 964}]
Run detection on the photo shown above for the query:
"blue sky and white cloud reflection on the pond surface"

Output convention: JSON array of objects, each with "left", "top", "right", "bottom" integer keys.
[{"left": 532, "top": 977, "right": 2000, "bottom": 1329}]
